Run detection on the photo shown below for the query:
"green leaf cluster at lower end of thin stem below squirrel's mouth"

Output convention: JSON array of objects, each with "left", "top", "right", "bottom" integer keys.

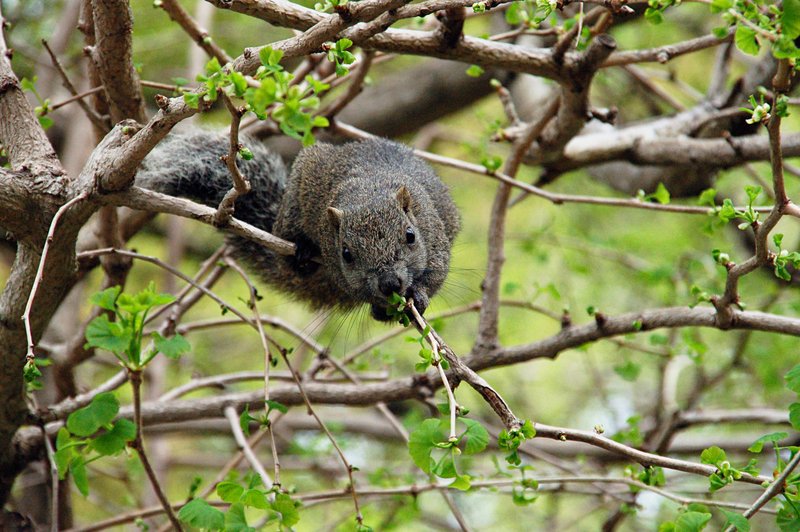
[{"left": 408, "top": 417, "right": 489, "bottom": 490}]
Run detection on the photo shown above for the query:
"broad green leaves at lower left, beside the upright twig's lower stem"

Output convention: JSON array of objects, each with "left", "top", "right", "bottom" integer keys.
[{"left": 55, "top": 392, "right": 136, "bottom": 496}]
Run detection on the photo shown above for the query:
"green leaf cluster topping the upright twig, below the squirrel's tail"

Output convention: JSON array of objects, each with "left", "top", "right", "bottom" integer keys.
[{"left": 86, "top": 282, "right": 191, "bottom": 371}]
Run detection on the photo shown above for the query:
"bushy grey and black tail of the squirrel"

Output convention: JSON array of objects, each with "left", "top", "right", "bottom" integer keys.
[{"left": 136, "top": 130, "right": 286, "bottom": 231}]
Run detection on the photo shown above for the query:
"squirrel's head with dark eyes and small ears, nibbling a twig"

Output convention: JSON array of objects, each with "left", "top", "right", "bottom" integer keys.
[{"left": 328, "top": 186, "right": 427, "bottom": 319}]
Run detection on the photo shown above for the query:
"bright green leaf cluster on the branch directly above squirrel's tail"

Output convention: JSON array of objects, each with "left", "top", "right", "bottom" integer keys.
[{"left": 183, "top": 46, "right": 330, "bottom": 146}]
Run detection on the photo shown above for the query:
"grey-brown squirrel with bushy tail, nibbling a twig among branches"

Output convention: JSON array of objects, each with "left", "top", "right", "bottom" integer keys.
[{"left": 136, "top": 131, "right": 460, "bottom": 321}]
